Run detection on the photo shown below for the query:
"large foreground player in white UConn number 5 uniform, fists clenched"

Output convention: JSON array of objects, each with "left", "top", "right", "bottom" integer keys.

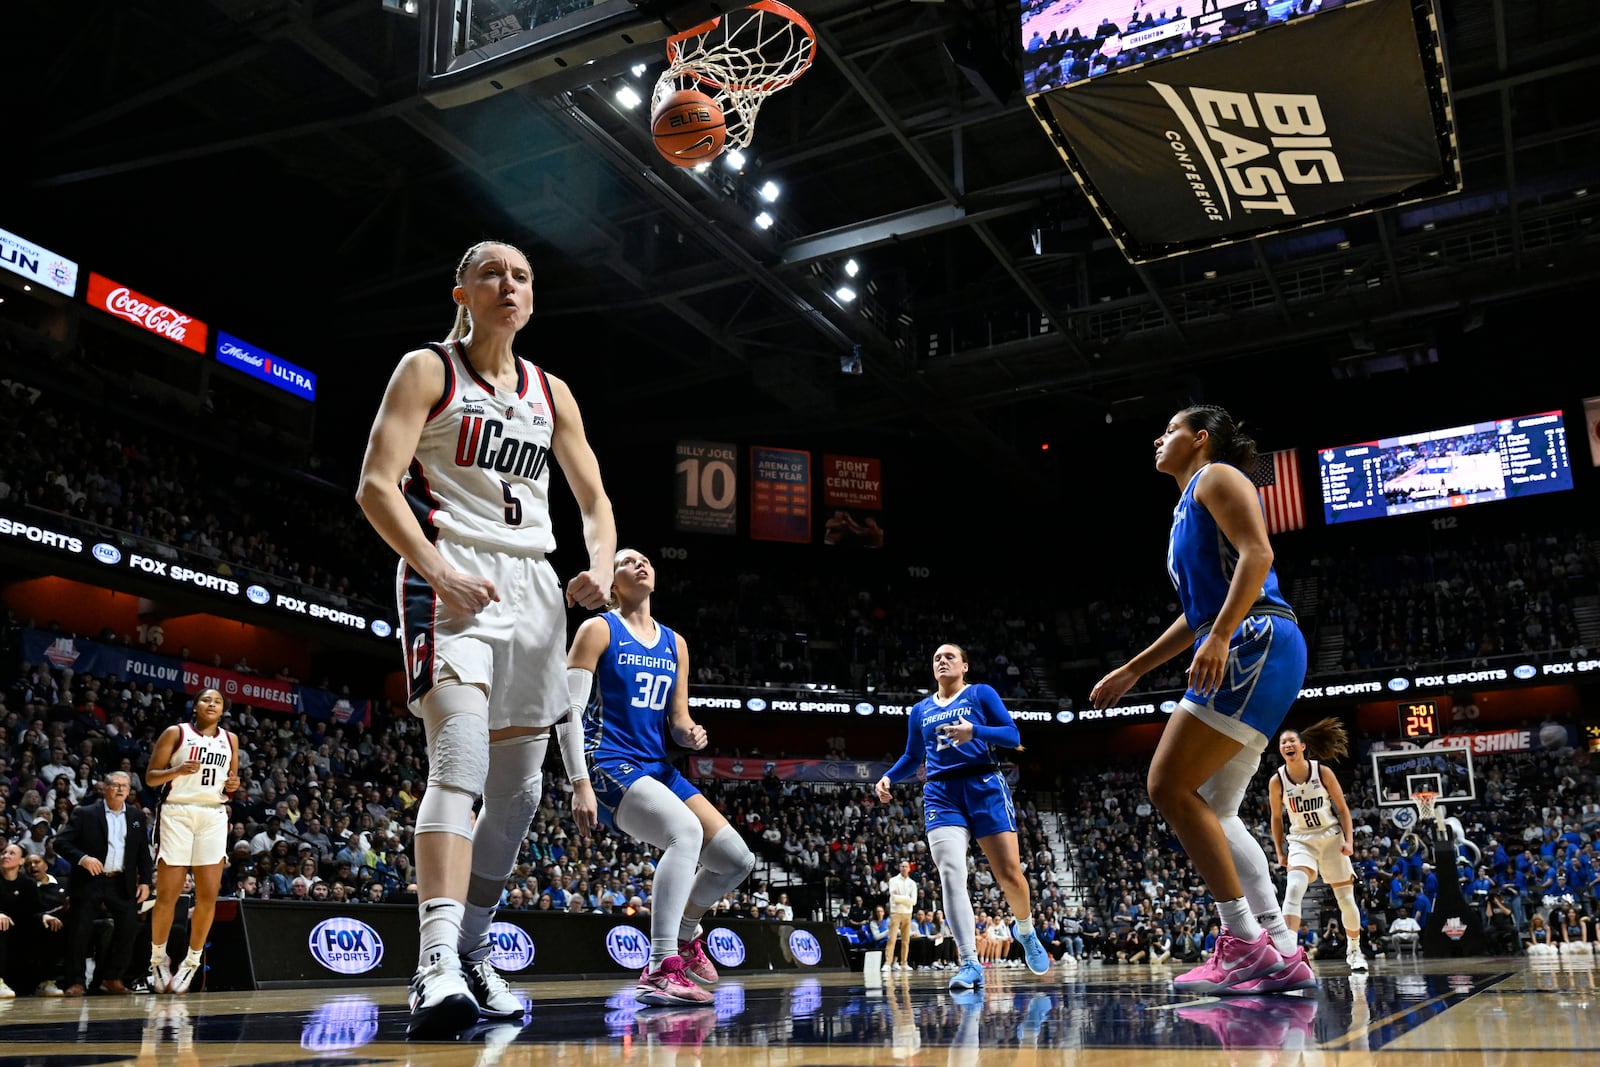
[{"left": 357, "top": 242, "right": 616, "bottom": 1040}]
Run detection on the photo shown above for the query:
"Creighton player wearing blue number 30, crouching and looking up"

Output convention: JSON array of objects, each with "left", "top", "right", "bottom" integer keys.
[{"left": 566, "top": 549, "right": 755, "bottom": 1005}]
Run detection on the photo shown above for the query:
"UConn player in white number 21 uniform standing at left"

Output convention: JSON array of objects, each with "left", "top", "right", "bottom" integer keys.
[{"left": 144, "top": 689, "right": 238, "bottom": 993}]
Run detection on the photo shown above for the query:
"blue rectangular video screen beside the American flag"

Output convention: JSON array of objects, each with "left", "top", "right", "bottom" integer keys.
[{"left": 1317, "top": 411, "right": 1573, "bottom": 525}]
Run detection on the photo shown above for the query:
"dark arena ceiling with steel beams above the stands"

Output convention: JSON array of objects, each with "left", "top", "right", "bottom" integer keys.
[{"left": 9, "top": 0, "right": 1600, "bottom": 483}]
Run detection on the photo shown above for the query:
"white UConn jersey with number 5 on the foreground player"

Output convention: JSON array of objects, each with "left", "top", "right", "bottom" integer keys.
[{"left": 402, "top": 341, "right": 555, "bottom": 555}]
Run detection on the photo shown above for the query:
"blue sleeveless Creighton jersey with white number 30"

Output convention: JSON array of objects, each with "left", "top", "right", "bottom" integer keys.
[{"left": 584, "top": 611, "right": 678, "bottom": 763}]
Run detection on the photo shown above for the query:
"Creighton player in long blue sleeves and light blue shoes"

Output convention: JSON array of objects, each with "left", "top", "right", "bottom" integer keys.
[{"left": 877, "top": 645, "right": 1050, "bottom": 992}]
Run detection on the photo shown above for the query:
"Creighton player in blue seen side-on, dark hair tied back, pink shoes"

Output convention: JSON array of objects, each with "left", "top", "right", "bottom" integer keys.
[{"left": 1090, "top": 405, "right": 1315, "bottom": 993}]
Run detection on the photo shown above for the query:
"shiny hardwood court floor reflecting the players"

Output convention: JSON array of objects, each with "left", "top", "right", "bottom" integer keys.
[{"left": 0, "top": 957, "right": 1600, "bottom": 1067}]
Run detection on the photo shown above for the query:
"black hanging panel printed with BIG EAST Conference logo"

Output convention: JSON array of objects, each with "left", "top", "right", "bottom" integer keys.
[{"left": 1029, "top": 0, "right": 1461, "bottom": 262}]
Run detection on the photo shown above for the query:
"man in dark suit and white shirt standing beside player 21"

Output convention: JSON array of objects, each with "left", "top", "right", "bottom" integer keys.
[{"left": 56, "top": 771, "right": 154, "bottom": 997}]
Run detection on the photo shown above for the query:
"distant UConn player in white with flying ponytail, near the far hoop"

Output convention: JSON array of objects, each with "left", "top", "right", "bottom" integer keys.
[{"left": 1270, "top": 718, "right": 1366, "bottom": 971}]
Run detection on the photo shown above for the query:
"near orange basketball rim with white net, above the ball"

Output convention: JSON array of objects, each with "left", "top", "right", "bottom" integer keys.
[{"left": 650, "top": 0, "right": 816, "bottom": 149}]
